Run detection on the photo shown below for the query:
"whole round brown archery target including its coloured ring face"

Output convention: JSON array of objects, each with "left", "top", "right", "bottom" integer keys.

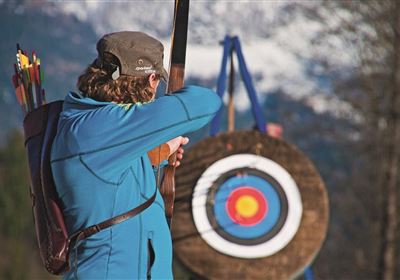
[{"left": 172, "top": 131, "right": 328, "bottom": 279}]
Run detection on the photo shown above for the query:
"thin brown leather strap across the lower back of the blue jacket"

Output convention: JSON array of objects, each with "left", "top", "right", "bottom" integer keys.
[{"left": 69, "top": 187, "right": 157, "bottom": 248}]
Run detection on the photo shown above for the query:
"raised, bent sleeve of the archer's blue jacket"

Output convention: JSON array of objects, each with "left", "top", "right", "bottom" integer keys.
[{"left": 66, "top": 86, "right": 221, "bottom": 182}]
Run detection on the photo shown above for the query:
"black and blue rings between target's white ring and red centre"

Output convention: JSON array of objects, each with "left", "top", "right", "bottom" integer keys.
[{"left": 206, "top": 167, "right": 288, "bottom": 245}]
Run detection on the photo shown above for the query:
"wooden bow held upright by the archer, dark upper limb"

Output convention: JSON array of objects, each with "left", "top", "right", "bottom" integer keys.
[{"left": 160, "top": 0, "right": 189, "bottom": 225}]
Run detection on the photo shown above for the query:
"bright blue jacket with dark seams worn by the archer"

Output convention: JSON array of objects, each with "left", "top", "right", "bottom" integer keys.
[{"left": 51, "top": 86, "right": 221, "bottom": 279}]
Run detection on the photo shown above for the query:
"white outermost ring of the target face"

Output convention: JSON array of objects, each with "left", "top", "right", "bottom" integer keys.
[{"left": 192, "top": 154, "right": 303, "bottom": 259}]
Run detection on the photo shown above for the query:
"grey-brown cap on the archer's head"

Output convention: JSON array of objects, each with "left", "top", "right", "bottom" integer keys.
[{"left": 96, "top": 31, "right": 168, "bottom": 81}]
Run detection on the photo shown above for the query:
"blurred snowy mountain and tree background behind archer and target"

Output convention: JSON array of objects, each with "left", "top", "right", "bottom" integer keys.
[{"left": 0, "top": 0, "right": 400, "bottom": 279}]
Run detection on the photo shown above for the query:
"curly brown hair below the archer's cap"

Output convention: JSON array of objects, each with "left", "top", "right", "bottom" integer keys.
[{"left": 77, "top": 54, "right": 160, "bottom": 103}]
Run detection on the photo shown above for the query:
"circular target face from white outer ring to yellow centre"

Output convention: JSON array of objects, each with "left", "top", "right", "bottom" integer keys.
[{"left": 192, "top": 154, "right": 302, "bottom": 258}]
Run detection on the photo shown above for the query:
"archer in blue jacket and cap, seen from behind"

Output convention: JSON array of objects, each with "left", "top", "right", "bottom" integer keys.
[{"left": 51, "top": 31, "right": 221, "bottom": 279}]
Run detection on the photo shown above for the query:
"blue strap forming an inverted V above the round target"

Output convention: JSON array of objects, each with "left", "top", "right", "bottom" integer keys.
[{"left": 210, "top": 36, "right": 266, "bottom": 136}]
